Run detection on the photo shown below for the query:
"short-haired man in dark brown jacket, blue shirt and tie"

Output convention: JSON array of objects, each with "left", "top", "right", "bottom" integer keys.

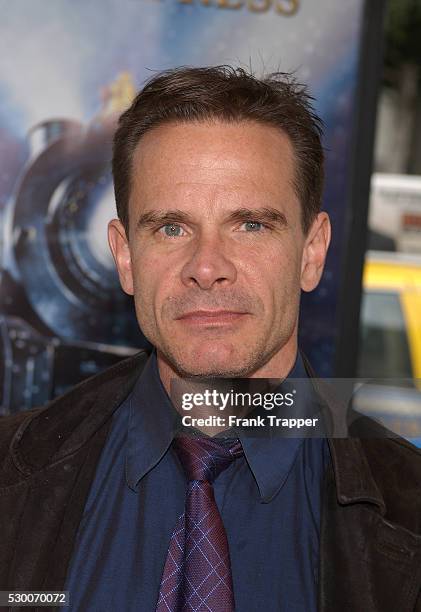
[{"left": 0, "top": 67, "right": 421, "bottom": 612}]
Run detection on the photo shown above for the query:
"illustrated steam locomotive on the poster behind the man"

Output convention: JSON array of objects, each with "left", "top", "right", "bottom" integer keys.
[{"left": 0, "top": 75, "right": 148, "bottom": 414}]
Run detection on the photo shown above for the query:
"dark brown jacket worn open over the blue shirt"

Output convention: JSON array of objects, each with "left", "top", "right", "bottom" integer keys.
[{"left": 0, "top": 351, "right": 421, "bottom": 612}]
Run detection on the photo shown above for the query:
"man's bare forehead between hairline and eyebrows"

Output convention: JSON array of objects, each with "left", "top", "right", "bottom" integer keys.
[{"left": 131, "top": 121, "right": 295, "bottom": 207}]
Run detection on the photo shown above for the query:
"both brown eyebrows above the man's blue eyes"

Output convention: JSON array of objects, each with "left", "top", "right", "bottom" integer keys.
[{"left": 136, "top": 206, "right": 288, "bottom": 230}]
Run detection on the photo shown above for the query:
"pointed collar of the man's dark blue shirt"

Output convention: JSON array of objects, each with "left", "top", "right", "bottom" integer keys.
[{"left": 126, "top": 350, "right": 307, "bottom": 503}]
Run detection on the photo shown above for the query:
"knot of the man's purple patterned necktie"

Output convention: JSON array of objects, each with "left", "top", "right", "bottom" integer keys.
[{"left": 174, "top": 436, "right": 243, "bottom": 482}]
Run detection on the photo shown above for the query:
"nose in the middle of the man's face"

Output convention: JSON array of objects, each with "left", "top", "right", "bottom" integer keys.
[{"left": 181, "top": 235, "right": 237, "bottom": 290}]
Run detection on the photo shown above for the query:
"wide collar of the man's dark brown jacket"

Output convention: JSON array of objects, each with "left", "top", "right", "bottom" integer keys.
[{"left": 11, "top": 350, "right": 386, "bottom": 514}]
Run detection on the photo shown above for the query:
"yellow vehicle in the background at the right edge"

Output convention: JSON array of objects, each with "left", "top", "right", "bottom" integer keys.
[{"left": 354, "top": 252, "right": 421, "bottom": 447}]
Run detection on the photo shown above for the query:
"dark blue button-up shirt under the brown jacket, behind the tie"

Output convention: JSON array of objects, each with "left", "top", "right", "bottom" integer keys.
[{"left": 65, "top": 351, "right": 330, "bottom": 612}]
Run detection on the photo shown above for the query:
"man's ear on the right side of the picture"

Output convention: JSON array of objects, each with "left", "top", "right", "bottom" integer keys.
[{"left": 301, "top": 212, "right": 331, "bottom": 291}]
